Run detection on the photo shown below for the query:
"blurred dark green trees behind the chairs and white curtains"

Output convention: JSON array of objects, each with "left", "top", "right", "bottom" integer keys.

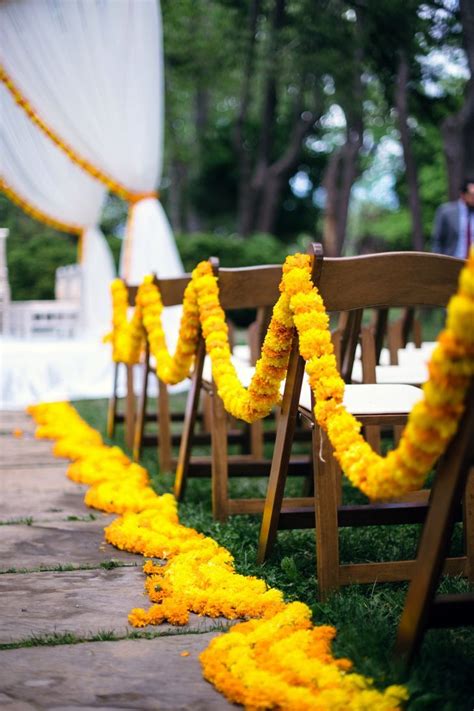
[{"left": 0, "top": 0, "right": 474, "bottom": 299}]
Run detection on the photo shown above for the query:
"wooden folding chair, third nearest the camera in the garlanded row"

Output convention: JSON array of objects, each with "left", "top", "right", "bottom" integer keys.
[{"left": 174, "top": 260, "right": 308, "bottom": 521}]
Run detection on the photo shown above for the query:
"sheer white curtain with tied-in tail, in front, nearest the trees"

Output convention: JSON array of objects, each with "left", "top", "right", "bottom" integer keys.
[{"left": 0, "top": 0, "right": 183, "bottom": 282}]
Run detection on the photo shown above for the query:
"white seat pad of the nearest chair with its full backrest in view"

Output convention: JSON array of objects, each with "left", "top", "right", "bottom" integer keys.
[{"left": 299, "top": 375, "right": 423, "bottom": 415}]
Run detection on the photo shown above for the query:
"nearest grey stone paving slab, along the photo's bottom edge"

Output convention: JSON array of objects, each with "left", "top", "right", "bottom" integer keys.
[{"left": 0, "top": 633, "right": 232, "bottom": 711}]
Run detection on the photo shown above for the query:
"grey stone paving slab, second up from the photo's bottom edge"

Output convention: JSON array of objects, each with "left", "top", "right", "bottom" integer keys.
[{"left": 0, "top": 568, "right": 229, "bottom": 644}]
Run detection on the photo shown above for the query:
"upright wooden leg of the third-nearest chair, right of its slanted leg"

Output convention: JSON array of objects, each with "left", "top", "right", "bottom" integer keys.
[{"left": 211, "top": 383, "right": 229, "bottom": 521}]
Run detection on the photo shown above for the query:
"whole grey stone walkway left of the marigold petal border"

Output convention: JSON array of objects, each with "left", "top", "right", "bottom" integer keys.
[{"left": 0, "top": 412, "right": 236, "bottom": 711}]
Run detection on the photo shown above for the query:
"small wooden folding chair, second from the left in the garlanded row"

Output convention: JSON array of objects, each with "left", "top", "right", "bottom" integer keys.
[{"left": 133, "top": 274, "right": 191, "bottom": 472}]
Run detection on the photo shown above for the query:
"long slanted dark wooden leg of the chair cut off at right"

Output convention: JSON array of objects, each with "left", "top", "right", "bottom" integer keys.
[{"left": 395, "top": 392, "right": 474, "bottom": 665}]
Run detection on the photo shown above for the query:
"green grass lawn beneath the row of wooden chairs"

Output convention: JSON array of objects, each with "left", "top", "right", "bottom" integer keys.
[{"left": 74, "top": 395, "right": 474, "bottom": 711}]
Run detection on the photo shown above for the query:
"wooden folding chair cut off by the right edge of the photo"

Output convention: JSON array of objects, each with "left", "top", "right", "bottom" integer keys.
[{"left": 395, "top": 382, "right": 474, "bottom": 665}]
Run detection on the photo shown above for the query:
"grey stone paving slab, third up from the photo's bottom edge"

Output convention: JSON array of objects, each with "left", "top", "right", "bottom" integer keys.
[{"left": 0, "top": 512, "right": 143, "bottom": 572}]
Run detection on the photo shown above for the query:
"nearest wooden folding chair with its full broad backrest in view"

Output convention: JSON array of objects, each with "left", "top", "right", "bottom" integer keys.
[{"left": 258, "top": 251, "right": 467, "bottom": 598}]
